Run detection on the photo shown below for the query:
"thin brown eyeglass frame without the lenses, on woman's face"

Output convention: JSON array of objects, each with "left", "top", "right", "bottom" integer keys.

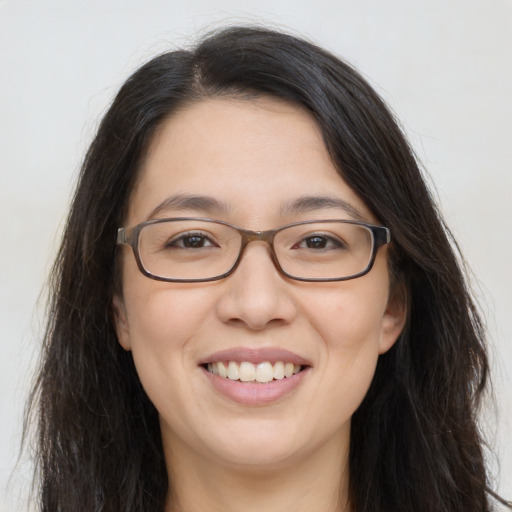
[{"left": 116, "top": 217, "right": 391, "bottom": 283}]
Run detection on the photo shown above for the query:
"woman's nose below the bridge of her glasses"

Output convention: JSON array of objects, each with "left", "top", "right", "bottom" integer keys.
[{"left": 217, "top": 242, "right": 297, "bottom": 331}]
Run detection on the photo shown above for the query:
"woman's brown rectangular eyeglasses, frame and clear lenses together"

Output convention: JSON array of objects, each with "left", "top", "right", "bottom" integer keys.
[{"left": 117, "top": 217, "right": 391, "bottom": 283}]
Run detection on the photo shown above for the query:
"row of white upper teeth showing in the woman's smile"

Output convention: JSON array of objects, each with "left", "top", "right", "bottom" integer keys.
[{"left": 203, "top": 361, "right": 305, "bottom": 384}]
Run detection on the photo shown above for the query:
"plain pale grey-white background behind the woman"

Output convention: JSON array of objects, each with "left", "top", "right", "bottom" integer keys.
[{"left": 0, "top": 0, "right": 512, "bottom": 512}]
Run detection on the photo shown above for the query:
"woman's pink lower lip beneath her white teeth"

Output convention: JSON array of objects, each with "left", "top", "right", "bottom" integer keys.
[{"left": 203, "top": 368, "right": 309, "bottom": 405}]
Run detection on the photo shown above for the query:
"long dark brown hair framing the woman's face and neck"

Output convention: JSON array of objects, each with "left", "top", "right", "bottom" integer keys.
[{"left": 27, "top": 27, "right": 510, "bottom": 512}]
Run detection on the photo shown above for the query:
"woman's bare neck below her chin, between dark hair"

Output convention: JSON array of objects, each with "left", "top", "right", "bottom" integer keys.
[{"left": 165, "top": 432, "right": 351, "bottom": 512}]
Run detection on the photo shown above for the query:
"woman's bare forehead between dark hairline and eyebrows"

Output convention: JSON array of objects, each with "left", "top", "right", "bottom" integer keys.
[{"left": 128, "top": 98, "right": 373, "bottom": 229}]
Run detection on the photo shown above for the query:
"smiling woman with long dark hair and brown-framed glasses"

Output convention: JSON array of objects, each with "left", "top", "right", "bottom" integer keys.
[{"left": 32, "top": 28, "right": 512, "bottom": 512}]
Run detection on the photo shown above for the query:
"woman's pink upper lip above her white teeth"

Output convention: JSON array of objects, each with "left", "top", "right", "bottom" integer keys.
[{"left": 199, "top": 347, "right": 311, "bottom": 366}]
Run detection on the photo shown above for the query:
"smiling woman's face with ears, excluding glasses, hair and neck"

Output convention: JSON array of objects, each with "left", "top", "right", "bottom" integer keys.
[{"left": 114, "top": 98, "right": 404, "bottom": 468}]
